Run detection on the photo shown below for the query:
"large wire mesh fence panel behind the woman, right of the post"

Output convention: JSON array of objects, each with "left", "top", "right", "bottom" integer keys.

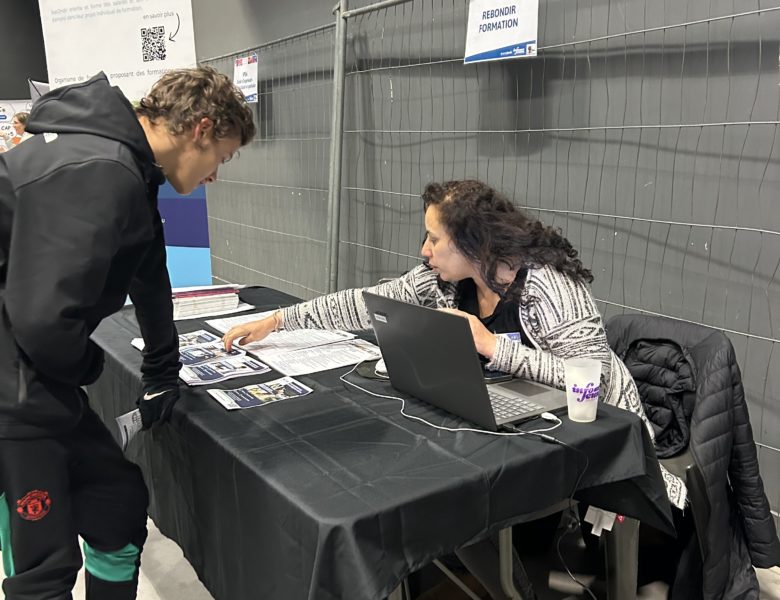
[{"left": 339, "top": 0, "right": 780, "bottom": 511}]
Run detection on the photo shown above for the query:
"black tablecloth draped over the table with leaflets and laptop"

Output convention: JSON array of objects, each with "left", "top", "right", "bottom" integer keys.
[{"left": 90, "top": 288, "right": 671, "bottom": 600}]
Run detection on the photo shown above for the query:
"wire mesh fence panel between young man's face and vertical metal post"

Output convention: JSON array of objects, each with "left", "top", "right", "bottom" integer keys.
[{"left": 205, "top": 26, "right": 334, "bottom": 297}]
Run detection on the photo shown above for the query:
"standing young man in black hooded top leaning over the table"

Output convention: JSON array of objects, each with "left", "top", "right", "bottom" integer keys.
[{"left": 0, "top": 68, "right": 255, "bottom": 600}]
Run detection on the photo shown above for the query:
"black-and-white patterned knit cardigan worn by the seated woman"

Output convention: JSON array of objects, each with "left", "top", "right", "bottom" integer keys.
[{"left": 283, "top": 265, "right": 686, "bottom": 509}]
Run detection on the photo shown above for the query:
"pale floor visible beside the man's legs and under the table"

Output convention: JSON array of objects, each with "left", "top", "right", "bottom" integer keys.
[{"left": 0, "top": 520, "right": 780, "bottom": 600}]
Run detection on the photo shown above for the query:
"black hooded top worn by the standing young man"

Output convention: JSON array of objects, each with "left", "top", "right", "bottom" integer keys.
[{"left": 0, "top": 73, "right": 180, "bottom": 438}]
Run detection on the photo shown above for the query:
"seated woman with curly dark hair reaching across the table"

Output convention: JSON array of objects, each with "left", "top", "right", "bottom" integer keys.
[{"left": 223, "top": 180, "right": 686, "bottom": 598}]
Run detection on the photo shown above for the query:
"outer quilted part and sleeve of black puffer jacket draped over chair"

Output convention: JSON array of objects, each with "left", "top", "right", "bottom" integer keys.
[{"left": 606, "top": 315, "right": 780, "bottom": 597}]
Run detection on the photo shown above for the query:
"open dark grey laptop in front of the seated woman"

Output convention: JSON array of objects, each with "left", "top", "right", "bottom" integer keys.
[{"left": 363, "top": 292, "right": 566, "bottom": 431}]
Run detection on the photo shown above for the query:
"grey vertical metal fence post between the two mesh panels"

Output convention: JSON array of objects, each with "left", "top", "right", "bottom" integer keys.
[{"left": 328, "top": 0, "right": 348, "bottom": 292}]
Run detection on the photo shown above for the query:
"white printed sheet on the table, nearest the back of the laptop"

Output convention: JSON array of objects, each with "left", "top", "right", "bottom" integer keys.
[{"left": 263, "top": 339, "right": 382, "bottom": 376}]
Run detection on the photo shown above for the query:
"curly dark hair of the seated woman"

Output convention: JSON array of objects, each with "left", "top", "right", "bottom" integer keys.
[{"left": 422, "top": 179, "right": 593, "bottom": 297}]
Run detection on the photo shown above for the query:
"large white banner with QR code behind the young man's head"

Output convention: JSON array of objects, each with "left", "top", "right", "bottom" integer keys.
[{"left": 38, "top": 0, "right": 196, "bottom": 100}]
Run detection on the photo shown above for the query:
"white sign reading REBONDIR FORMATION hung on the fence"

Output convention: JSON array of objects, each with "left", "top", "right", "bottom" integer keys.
[{"left": 463, "top": 0, "right": 539, "bottom": 63}]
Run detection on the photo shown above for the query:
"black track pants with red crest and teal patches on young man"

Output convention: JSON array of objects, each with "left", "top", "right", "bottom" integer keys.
[{"left": 0, "top": 404, "right": 148, "bottom": 600}]
